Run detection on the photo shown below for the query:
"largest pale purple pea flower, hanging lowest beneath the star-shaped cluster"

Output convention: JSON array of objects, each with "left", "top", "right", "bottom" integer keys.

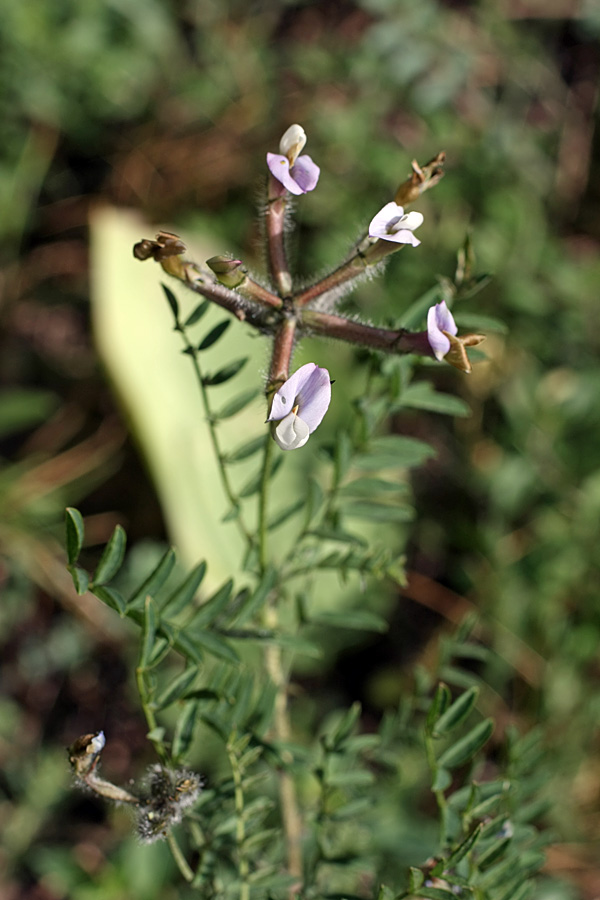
[{"left": 267, "top": 363, "right": 331, "bottom": 450}]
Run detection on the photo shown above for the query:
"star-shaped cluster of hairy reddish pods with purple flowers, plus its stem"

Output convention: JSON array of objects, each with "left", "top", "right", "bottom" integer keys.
[{"left": 134, "top": 125, "right": 483, "bottom": 884}]
